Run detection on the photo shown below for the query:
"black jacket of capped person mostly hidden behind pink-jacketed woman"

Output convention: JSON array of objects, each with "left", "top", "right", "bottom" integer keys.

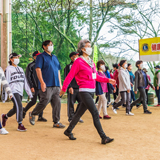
[{"left": 64, "top": 62, "right": 79, "bottom": 89}]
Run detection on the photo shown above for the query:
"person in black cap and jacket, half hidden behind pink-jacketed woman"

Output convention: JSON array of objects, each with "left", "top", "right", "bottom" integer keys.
[{"left": 64, "top": 52, "right": 83, "bottom": 123}]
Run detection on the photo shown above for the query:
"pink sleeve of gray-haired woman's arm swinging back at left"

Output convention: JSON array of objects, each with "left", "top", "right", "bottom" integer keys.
[{"left": 62, "top": 63, "right": 79, "bottom": 92}]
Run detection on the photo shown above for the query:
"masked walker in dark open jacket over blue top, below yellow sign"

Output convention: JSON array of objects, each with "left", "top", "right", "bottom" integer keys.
[{"left": 131, "top": 60, "right": 155, "bottom": 114}]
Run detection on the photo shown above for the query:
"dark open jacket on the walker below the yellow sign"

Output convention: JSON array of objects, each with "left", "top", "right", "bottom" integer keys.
[{"left": 134, "top": 69, "right": 153, "bottom": 91}]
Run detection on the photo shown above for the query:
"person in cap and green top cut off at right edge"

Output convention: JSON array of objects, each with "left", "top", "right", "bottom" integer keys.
[{"left": 154, "top": 65, "right": 160, "bottom": 107}]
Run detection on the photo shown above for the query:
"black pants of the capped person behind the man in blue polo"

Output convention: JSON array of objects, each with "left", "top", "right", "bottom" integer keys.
[{"left": 23, "top": 89, "right": 43, "bottom": 118}]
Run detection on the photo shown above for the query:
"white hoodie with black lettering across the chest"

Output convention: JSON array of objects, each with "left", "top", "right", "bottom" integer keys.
[{"left": 5, "top": 65, "right": 33, "bottom": 101}]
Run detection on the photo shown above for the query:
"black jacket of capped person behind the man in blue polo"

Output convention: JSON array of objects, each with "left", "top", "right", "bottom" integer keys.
[{"left": 26, "top": 60, "right": 38, "bottom": 89}]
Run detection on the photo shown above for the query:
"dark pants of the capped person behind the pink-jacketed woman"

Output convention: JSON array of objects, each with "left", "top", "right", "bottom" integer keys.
[{"left": 67, "top": 89, "right": 81, "bottom": 121}]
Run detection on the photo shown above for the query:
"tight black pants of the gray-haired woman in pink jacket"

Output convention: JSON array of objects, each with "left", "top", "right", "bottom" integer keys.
[{"left": 67, "top": 92, "right": 106, "bottom": 139}]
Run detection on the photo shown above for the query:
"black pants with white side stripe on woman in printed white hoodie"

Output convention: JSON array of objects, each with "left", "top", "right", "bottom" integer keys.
[{"left": 7, "top": 93, "right": 23, "bottom": 123}]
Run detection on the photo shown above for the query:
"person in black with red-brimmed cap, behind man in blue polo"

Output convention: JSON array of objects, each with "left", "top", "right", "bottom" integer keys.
[{"left": 23, "top": 51, "right": 47, "bottom": 122}]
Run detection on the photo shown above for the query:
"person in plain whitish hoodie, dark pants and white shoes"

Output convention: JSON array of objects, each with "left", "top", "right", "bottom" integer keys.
[{"left": 112, "top": 60, "right": 134, "bottom": 116}]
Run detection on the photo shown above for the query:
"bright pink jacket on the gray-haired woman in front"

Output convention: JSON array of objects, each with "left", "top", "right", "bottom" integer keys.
[{"left": 62, "top": 58, "right": 109, "bottom": 92}]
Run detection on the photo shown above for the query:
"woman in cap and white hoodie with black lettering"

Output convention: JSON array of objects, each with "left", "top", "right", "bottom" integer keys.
[{"left": 2, "top": 53, "right": 32, "bottom": 131}]
